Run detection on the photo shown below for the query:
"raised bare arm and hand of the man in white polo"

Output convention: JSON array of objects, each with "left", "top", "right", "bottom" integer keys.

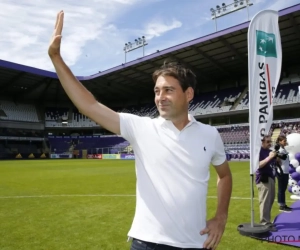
[{"left": 48, "top": 11, "right": 120, "bottom": 134}]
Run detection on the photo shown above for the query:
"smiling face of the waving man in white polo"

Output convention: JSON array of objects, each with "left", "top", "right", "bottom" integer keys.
[{"left": 154, "top": 76, "right": 194, "bottom": 120}]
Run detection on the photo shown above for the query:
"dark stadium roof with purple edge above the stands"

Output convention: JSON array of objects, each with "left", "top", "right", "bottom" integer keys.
[{"left": 0, "top": 4, "right": 300, "bottom": 103}]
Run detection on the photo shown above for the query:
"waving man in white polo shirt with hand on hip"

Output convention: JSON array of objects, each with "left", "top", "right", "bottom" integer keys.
[{"left": 48, "top": 12, "right": 232, "bottom": 250}]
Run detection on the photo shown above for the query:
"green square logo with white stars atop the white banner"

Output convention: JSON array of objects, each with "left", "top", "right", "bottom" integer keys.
[{"left": 256, "top": 30, "right": 277, "bottom": 58}]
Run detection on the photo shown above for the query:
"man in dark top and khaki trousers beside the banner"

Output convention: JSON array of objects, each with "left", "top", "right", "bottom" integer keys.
[{"left": 256, "top": 136, "right": 277, "bottom": 231}]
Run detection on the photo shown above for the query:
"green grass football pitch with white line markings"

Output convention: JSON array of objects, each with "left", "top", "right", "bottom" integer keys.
[{"left": 0, "top": 159, "right": 293, "bottom": 250}]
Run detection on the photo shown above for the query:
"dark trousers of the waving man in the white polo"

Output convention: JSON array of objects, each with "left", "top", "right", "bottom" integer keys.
[{"left": 130, "top": 239, "right": 210, "bottom": 250}]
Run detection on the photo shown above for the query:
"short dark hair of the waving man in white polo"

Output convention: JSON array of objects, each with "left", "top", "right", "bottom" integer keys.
[{"left": 152, "top": 59, "right": 197, "bottom": 92}]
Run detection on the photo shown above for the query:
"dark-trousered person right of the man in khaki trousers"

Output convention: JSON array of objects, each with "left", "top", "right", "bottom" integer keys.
[{"left": 275, "top": 135, "right": 292, "bottom": 213}]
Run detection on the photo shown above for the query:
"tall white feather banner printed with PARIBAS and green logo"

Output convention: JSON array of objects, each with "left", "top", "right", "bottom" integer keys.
[{"left": 248, "top": 10, "right": 282, "bottom": 174}]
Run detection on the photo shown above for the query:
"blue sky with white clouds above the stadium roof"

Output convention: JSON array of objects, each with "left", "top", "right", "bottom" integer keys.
[{"left": 0, "top": 0, "right": 300, "bottom": 76}]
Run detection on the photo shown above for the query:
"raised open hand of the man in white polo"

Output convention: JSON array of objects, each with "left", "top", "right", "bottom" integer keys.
[{"left": 48, "top": 11, "right": 64, "bottom": 57}]
